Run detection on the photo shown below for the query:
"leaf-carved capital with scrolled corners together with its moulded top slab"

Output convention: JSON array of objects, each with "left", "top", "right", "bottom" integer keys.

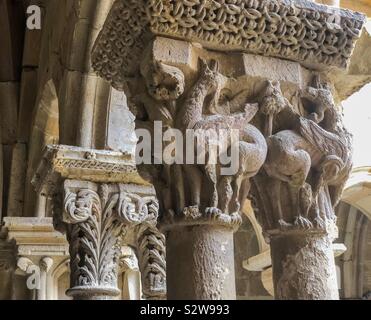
[{"left": 33, "top": 146, "right": 164, "bottom": 300}]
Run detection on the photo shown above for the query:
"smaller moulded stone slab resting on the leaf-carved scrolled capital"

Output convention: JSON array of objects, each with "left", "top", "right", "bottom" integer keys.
[{"left": 32, "top": 145, "right": 148, "bottom": 193}]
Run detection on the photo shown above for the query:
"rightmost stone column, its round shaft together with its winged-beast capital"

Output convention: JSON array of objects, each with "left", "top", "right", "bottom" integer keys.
[{"left": 250, "top": 76, "right": 352, "bottom": 300}]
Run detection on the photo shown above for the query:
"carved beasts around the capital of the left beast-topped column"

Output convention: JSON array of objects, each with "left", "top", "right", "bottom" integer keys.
[{"left": 135, "top": 59, "right": 267, "bottom": 222}]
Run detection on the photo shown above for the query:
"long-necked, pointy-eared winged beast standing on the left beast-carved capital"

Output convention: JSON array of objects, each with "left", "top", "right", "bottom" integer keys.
[{"left": 176, "top": 60, "right": 267, "bottom": 212}]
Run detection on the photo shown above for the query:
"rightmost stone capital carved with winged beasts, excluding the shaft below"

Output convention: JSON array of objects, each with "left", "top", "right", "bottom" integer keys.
[{"left": 251, "top": 75, "right": 352, "bottom": 238}]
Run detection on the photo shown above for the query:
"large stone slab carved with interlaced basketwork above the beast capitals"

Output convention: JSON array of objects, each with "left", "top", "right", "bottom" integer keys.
[{"left": 92, "top": 0, "right": 366, "bottom": 89}]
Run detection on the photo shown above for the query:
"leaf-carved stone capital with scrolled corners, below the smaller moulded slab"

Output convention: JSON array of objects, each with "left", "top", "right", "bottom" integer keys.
[{"left": 54, "top": 180, "right": 158, "bottom": 299}]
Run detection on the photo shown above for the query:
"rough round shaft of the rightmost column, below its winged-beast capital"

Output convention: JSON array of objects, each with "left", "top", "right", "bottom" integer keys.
[{"left": 270, "top": 231, "right": 339, "bottom": 300}]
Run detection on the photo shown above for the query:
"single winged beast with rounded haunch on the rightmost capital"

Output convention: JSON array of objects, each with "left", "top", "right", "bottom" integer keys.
[{"left": 264, "top": 77, "right": 352, "bottom": 229}]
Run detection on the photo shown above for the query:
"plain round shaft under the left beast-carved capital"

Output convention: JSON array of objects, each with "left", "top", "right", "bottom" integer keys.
[{"left": 166, "top": 225, "right": 236, "bottom": 300}]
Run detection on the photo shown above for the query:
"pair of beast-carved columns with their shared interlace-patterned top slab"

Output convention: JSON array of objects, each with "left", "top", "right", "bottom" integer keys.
[{"left": 92, "top": 0, "right": 365, "bottom": 299}]
